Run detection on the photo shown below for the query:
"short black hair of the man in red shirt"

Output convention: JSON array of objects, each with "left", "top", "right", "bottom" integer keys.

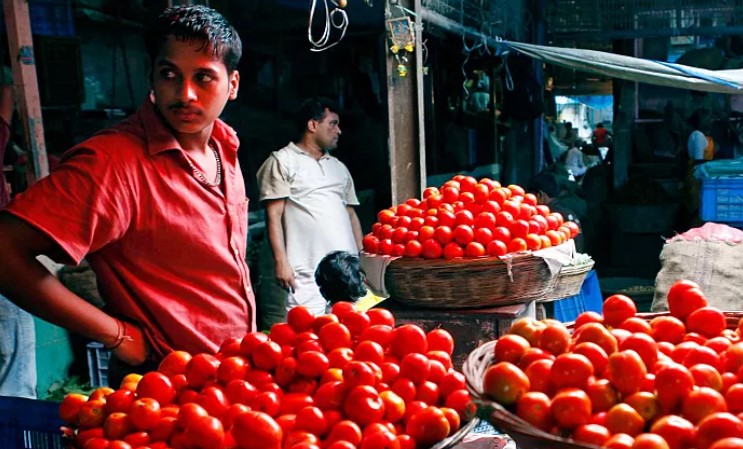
[{"left": 145, "top": 5, "right": 242, "bottom": 72}]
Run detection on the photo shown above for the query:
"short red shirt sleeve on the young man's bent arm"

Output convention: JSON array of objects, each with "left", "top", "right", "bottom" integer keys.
[{"left": 6, "top": 147, "right": 132, "bottom": 264}]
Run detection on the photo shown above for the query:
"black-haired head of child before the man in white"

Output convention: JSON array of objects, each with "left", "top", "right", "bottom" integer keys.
[{"left": 315, "top": 251, "right": 366, "bottom": 303}]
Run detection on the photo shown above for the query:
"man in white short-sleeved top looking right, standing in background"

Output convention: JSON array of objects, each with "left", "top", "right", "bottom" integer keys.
[{"left": 258, "top": 98, "right": 362, "bottom": 315}]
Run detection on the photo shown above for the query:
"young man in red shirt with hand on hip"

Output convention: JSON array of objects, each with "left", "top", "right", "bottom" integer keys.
[{"left": 0, "top": 6, "right": 255, "bottom": 387}]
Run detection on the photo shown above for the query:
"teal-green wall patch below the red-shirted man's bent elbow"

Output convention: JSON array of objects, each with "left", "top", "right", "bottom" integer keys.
[{"left": 34, "top": 317, "right": 74, "bottom": 399}]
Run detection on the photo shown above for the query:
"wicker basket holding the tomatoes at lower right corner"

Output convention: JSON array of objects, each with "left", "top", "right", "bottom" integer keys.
[{"left": 462, "top": 312, "right": 743, "bottom": 449}]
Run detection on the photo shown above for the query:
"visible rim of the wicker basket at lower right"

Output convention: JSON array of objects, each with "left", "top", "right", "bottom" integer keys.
[{"left": 462, "top": 311, "right": 743, "bottom": 449}]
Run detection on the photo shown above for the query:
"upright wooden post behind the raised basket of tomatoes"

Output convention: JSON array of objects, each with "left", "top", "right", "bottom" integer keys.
[{"left": 385, "top": 0, "right": 421, "bottom": 204}]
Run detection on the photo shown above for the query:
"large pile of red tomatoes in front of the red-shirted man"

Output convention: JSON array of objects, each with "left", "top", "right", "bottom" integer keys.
[{"left": 59, "top": 302, "right": 475, "bottom": 449}]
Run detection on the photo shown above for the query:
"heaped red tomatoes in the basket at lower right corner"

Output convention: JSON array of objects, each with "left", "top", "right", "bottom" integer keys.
[{"left": 483, "top": 281, "right": 743, "bottom": 449}]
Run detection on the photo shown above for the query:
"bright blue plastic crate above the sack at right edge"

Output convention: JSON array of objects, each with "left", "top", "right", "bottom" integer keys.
[{"left": 699, "top": 177, "right": 743, "bottom": 223}]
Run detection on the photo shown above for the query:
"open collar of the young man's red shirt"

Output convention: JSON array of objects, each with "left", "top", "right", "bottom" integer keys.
[{"left": 135, "top": 98, "right": 240, "bottom": 156}]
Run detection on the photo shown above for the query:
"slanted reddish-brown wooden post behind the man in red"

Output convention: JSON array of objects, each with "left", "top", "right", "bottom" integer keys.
[{"left": 3, "top": 0, "right": 49, "bottom": 182}]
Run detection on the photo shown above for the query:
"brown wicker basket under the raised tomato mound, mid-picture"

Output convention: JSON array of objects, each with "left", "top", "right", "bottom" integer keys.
[{"left": 384, "top": 250, "right": 555, "bottom": 309}]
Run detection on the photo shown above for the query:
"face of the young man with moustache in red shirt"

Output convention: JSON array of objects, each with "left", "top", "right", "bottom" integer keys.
[{"left": 152, "top": 36, "right": 240, "bottom": 138}]
